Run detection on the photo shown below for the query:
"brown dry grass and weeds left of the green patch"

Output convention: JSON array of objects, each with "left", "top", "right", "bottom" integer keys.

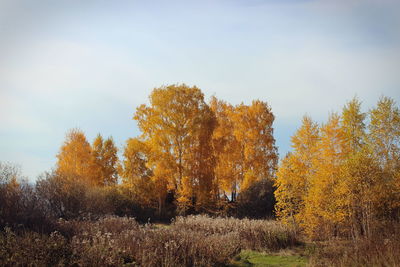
[{"left": 0, "top": 216, "right": 296, "bottom": 266}]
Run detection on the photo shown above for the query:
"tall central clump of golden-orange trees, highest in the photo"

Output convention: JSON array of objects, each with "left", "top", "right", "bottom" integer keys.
[{"left": 121, "top": 84, "right": 277, "bottom": 215}]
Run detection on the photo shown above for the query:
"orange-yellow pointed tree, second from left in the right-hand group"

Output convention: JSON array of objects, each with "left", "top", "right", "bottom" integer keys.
[{"left": 303, "top": 114, "right": 349, "bottom": 238}]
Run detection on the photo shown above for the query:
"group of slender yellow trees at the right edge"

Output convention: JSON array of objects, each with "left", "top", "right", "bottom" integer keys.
[{"left": 275, "top": 97, "right": 400, "bottom": 239}]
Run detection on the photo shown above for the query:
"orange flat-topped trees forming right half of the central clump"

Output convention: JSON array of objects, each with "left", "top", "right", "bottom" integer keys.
[{"left": 210, "top": 97, "right": 277, "bottom": 205}]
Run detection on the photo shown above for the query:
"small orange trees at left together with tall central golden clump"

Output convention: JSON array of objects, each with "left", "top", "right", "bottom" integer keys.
[{"left": 50, "top": 84, "right": 278, "bottom": 221}]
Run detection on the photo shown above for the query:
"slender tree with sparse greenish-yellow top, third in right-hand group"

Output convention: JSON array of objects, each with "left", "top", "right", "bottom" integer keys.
[{"left": 341, "top": 98, "right": 381, "bottom": 238}]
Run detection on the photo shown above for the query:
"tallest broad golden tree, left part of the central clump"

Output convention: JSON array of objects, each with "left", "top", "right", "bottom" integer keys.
[{"left": 134, "top": 84, "right": 215, "bottom": 215}]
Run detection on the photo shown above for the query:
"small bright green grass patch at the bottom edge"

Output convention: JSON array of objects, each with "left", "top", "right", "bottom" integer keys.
[{"left": 229, "top": 250, "right": 307, "bottom": 267}]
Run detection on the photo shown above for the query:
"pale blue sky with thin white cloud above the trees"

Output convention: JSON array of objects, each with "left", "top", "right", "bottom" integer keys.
[{"left": 0, "top": 0, "right": 400, "bottom": 181}]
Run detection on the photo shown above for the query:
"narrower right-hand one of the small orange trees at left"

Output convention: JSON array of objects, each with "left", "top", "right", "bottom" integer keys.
[{"left": 92, "top": 134, "right": 118, "bottom": 185}]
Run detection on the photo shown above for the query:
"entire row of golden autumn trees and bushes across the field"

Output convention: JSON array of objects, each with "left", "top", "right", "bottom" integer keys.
[{"left": 0, "top": 84, "right": 400, "bottom": 239}]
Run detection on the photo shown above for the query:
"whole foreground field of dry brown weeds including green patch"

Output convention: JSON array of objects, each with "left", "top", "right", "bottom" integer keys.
[{"left": 0, "top": 215, "right": 400, "bottom": 267}]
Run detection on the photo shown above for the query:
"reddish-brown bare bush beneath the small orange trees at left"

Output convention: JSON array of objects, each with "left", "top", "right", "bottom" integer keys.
[{"left": 35, "top": 173, "right": 163, "bottom": 222}]
